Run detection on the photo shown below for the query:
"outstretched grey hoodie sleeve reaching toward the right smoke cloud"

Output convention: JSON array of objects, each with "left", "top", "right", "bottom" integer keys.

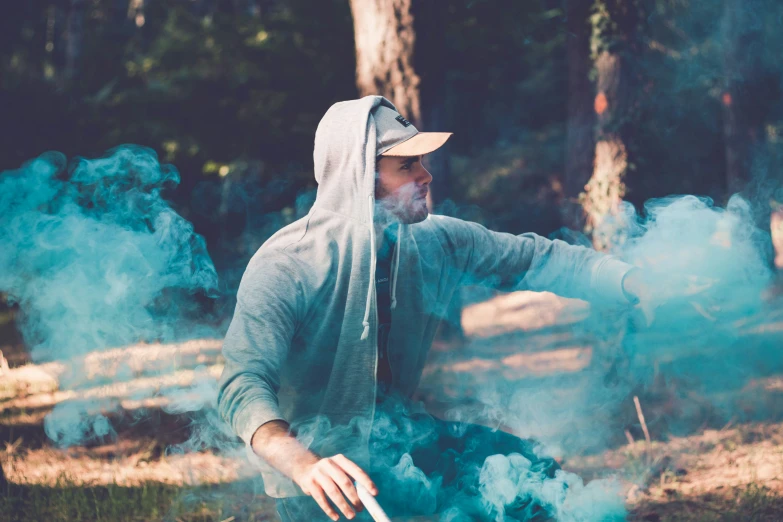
[{"left": 440, "top": 216, "right": 634, "bottom": 304}]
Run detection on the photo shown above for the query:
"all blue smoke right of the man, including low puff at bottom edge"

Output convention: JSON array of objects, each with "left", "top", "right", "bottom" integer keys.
[{"left": 426, "top": 196, "right": 783, "bottom": 521}]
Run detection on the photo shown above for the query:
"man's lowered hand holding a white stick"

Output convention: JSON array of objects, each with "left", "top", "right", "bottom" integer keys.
[{"left": 292, "top": 448, "right": 378, "bottom": 520}]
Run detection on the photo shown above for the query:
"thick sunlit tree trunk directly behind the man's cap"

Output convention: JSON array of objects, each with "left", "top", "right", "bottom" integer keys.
[{"left": 351, "top": 0, "right": 421, "bottom": 125}]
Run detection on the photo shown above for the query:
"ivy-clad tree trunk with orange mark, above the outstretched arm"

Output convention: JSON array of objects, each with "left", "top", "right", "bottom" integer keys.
[{"left": 580, "top": 0, "right": 646, "bottom": 250}]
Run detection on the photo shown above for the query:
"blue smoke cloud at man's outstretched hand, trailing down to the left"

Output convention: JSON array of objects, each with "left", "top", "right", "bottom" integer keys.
[{"left": 490, "top": 191, "right": 783, "bottom": 442}]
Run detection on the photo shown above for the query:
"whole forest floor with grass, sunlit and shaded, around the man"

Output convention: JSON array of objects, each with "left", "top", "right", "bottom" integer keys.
[{"left": 0, "top": 292, "right": 783, "bottom": 522}]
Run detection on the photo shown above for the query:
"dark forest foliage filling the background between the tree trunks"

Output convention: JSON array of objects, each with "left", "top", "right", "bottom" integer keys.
[{"left": 0, "top": 0, "right": 783, "bottom": 249}]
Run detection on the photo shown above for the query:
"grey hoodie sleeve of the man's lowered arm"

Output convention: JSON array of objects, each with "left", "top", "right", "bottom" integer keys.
[{"left": 218, "top": 252, "right": 303, "bottom": 444}]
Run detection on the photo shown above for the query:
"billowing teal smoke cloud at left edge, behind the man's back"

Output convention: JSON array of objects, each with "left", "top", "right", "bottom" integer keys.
[{"left": 0, "top": 145, "right": 217, "bottom": 446}]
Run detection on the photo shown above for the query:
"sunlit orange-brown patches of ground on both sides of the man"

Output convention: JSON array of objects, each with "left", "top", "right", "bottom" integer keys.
[{"left": 0, "top": 292, "right": 783, "bottom": 520}]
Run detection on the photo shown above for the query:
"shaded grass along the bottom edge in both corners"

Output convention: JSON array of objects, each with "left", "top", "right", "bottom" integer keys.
[{"left": 0, "top": 482, "right": 783, "bottom": 522}]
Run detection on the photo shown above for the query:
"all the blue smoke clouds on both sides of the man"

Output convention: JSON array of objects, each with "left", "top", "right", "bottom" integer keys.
[{"left": 0, "top": 146, "right": 783, "bottom": 522}]
